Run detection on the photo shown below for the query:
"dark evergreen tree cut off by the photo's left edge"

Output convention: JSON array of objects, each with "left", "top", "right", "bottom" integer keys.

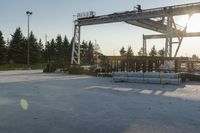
[{"left": 0, "top": 31, "right": 6, "bottom": 64}]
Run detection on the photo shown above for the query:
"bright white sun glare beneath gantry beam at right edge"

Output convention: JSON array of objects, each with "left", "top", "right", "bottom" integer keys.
[{"left": 187, "top": 14, "right": 200, "bottom": 32}]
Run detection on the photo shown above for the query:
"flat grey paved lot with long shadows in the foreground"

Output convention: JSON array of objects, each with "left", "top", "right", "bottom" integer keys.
[{"left": 0, "top": 70, "right": 200, "bottom": 133}]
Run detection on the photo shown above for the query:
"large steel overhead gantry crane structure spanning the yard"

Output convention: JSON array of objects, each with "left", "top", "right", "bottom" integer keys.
[{"left": 71, "top": 2, "right": 200, "bottom": 65}]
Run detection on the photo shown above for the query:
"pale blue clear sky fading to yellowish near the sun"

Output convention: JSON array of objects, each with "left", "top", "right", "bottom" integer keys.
[{"left": 0, "top": 0, "right": 200, "bottom": 56}]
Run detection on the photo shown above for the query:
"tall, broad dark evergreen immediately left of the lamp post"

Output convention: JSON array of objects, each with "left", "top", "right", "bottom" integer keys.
[{"left": 8, "top": 27, "right": 27, "bottom": 64}]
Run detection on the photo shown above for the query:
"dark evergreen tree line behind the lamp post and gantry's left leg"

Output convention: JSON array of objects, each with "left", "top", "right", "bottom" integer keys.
[{"left": 0, "top": 27, "right": 95, "bottom": 65}]
